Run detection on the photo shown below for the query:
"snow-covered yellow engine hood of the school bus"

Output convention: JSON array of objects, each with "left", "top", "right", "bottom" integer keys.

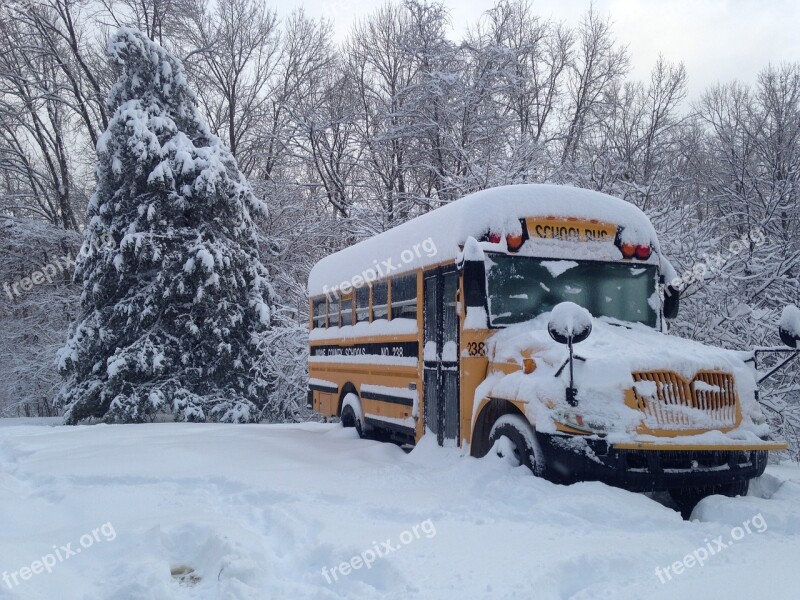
[{"left": 476, "top": 313, "right": 769, "bottom": 439}]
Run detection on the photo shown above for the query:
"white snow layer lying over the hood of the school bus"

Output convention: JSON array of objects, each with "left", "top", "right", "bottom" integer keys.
[{"left": 476, "top": 313, "right": 768, "bottom": 436}]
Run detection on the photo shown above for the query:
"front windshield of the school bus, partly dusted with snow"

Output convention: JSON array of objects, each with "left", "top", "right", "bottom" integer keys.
[{"left": 487, "top": 253, "right": 658, "bottom": 327}]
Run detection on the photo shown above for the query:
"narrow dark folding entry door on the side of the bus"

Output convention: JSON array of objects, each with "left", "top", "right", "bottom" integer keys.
[{"left": 423, "top": 267, "right": 459, "bottom": 446}]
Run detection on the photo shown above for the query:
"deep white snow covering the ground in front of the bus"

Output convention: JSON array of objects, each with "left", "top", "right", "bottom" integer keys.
[{"left": 0, "top": 422, "right": 800, "bottom": 600}]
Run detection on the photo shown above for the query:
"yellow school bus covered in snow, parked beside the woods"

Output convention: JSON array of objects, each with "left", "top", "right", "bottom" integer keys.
[{"left": 308, "top": 185, "right": 796, "bottom": 507}]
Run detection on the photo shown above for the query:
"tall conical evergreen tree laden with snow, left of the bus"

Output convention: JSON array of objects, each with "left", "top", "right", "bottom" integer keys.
[{"left": 56, "top": 28, "right": 273, "bottom": 424}]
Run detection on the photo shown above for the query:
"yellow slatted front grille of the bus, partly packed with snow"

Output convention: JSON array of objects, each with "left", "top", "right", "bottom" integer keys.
[{"left": 633, "top": 371, "right": 737, "bottom": 430}]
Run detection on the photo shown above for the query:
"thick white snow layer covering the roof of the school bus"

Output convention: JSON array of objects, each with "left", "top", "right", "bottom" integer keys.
[{"left": 308, "top": 184, "right": 660, "bottom": 296}]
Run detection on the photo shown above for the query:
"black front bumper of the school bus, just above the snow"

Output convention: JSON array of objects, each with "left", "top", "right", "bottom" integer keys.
[{"left": 536, "top": 432, "right": 770, "bottom": 492}]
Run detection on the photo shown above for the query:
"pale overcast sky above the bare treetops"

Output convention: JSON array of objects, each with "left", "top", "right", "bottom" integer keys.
[{"left": 280, "top": 0, "right": 800, "bottom": 97}]
